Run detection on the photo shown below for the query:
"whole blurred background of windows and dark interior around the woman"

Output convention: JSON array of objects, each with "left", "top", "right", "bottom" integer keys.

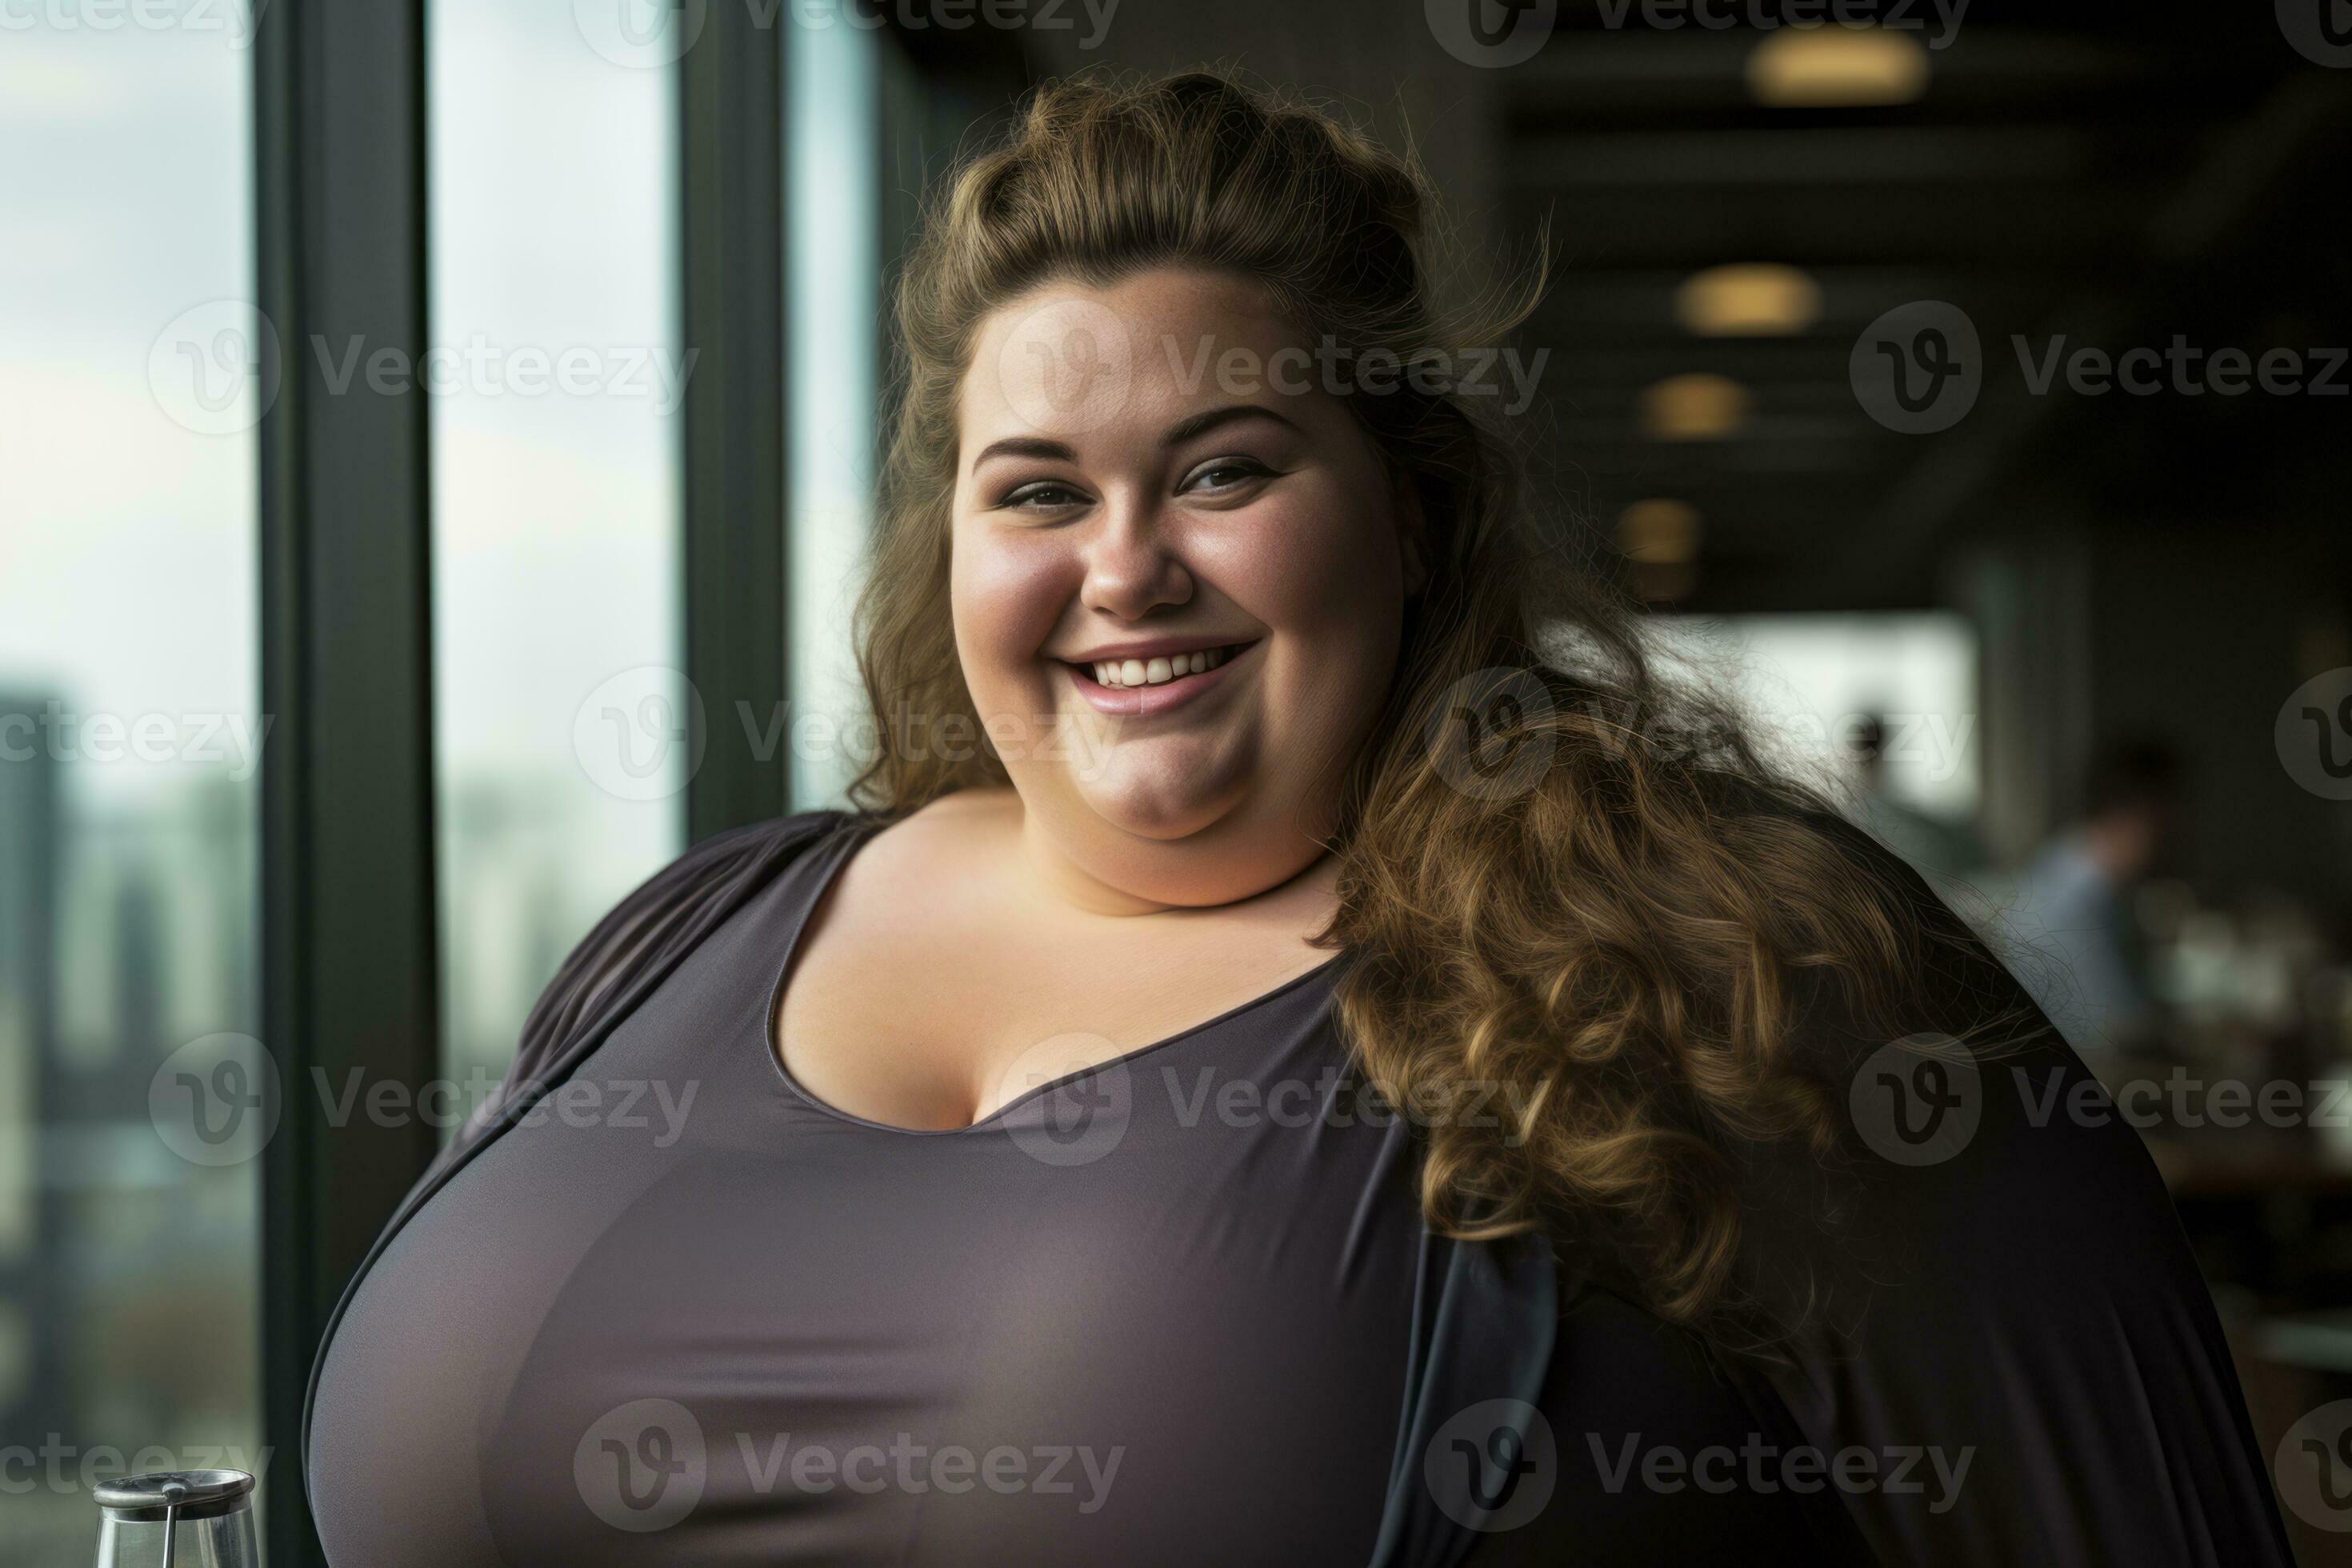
[{"left": 0, "top": 0, "right": 2352, "bottom": 1563}]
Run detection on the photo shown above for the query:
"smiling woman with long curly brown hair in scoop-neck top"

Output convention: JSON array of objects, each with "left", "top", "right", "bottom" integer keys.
[{"left": 306, "top": 75, "right": 2286, "bottom": 1566}]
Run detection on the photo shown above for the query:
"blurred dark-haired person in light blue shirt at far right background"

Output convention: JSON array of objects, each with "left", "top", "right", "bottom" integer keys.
[{"left": 2018, "top": 741, "right": 2182, "bottom": 1051}]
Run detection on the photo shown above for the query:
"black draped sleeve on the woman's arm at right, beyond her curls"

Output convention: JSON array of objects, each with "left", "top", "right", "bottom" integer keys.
[{"left": 1726, "top": 825, "right": 2294, "bottom": 1568}]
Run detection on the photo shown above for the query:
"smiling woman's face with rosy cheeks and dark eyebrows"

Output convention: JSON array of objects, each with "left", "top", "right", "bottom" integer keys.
[{"left": 953, "top": 268, "right": 1418, "bottom": 905}]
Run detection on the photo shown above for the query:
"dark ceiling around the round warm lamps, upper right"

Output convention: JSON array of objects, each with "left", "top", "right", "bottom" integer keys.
[{"left": 1496, "top": 0, "right": 2352, "bottom": 611}]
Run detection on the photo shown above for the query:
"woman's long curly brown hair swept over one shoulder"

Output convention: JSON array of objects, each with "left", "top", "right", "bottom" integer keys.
[{"left": 851, "top": 73, "right": 2032, "bottom": 1347}]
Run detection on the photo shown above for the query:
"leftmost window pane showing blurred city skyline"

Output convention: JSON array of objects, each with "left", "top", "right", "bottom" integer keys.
[{"left": 0, "top": 2, "right": 259, "bottom": 1563}]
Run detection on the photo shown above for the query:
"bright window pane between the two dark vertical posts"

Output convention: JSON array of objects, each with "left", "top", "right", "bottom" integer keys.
[{"left": 428, "top": 0, "right": 694, "bottom": 1105}]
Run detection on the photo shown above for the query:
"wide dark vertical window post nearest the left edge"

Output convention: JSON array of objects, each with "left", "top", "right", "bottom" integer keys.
[{"left": 254, "top": 0, "right": 440, "bottom": 1568}]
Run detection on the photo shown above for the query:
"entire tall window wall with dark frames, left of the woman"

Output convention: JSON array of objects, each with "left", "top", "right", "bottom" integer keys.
[{"left": 0, "top": 12, "right": 982, "bottom": 1561}]
